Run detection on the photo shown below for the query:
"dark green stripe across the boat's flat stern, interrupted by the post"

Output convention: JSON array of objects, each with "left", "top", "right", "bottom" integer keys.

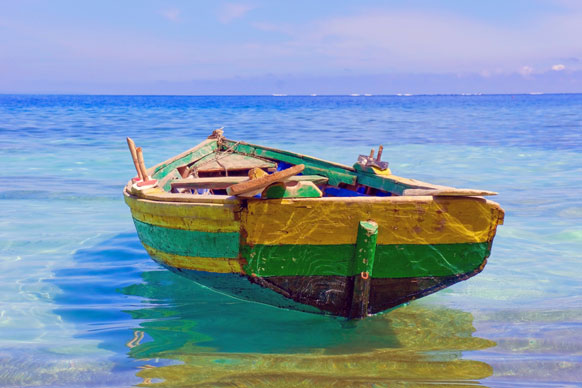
[{"left": 243, "top": 242, "right": 489, "bottom": 278}]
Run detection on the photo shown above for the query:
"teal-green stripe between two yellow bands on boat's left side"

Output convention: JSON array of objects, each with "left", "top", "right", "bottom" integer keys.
[{"left": 133, "top": 218, "right": 240, "bottom": 258}]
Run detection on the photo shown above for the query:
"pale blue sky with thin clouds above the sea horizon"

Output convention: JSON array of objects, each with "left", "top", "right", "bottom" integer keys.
[{"left": 0, "top": 0, "right": 582, "bottom": 95}]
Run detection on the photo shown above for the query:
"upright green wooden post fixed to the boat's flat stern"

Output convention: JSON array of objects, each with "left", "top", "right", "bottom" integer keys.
[{"left": 349, "top": 221, "right": 378, "bottom": 319}]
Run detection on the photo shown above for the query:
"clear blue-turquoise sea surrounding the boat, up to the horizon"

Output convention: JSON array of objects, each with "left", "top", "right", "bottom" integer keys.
[{"left": 0, "top": 95, "right": 582, "bottom": 387}]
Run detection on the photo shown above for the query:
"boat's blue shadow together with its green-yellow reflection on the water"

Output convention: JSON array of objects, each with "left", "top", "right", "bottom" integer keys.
[{"left": 51, "top": 233, "right": 495, "bottom": 387}]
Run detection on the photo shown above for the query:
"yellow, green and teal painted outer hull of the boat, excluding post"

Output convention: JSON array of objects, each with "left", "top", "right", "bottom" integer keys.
[{"left": 125, "top": 191, "right": 503, "bottom": 317}]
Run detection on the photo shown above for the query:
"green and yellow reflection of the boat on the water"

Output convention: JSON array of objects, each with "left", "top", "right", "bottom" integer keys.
[{"left": 121, "top": 271, "right": 495, "bottom": 387}]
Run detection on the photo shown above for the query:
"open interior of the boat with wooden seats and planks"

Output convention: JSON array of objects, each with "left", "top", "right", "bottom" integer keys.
[{"left": 128, "top": 130, "right": 496, "bottom": 199}]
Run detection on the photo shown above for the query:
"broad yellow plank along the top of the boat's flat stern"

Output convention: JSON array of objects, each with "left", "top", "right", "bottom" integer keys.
[{"left": 243, "top": 196, "right": 502, "bottom": 245}]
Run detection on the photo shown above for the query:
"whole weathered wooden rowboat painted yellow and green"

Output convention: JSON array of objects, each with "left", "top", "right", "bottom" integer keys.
[{"left": 124, "top": 130, "right": 504, "bottom": 318}]
